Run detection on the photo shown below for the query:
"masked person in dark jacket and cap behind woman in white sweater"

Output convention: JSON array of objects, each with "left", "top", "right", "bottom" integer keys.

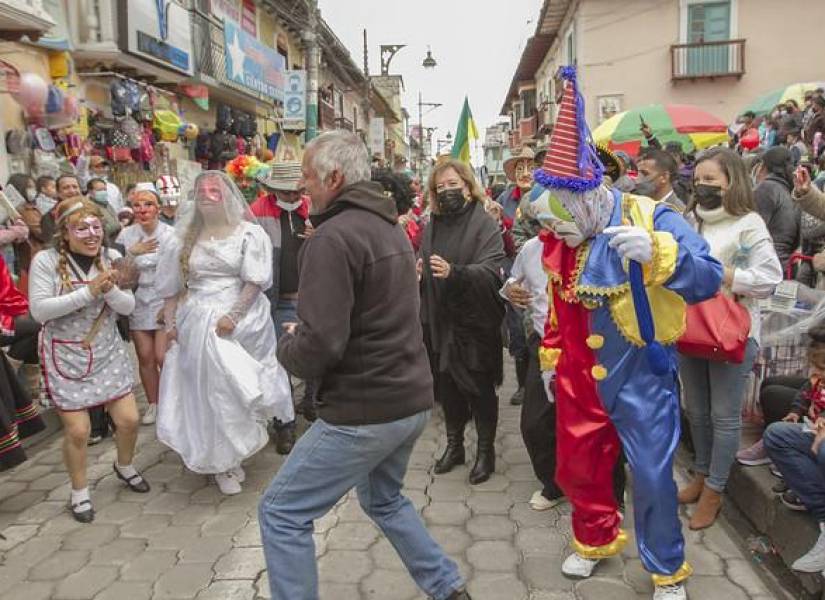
[{"left": 752, "top": 146, "right": 801, "bottom": 272}]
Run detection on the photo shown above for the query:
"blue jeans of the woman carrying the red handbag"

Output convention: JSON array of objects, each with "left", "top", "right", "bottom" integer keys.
[{"left": 679, "top": 338, "right": 759, "bottom": 493}]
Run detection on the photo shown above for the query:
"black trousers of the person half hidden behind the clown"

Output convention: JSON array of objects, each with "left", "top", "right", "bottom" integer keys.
[{"left": 521, "top": 333, "right": 625, "bottom": 506}]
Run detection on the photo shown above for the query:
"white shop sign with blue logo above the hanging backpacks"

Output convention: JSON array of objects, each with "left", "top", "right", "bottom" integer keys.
[{"left": 124, "top": 0, "right": 192, "bottom": 75}]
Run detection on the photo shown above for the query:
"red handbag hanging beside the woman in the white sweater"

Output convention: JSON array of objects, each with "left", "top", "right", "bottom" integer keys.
[{"left": 676, "top": 292, "right": 751, "bottom": 364}]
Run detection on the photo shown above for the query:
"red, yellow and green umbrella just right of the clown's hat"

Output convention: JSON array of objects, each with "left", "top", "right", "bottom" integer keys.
[{"left": 593, "top": 104, "right": 728, "bottom": 156}]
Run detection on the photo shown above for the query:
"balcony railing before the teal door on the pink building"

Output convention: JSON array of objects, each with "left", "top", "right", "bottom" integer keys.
[{"left": 670, "top": 40, "right": 745, "bottom": 81}]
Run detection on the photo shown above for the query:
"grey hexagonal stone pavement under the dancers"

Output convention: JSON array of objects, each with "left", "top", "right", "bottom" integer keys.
[{"left": 0, "top": 375, "right": 777, "bottom": 600}]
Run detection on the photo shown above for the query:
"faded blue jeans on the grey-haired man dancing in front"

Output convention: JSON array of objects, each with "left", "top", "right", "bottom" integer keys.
[{"left": 258, "top": 410, "right": 464, "bottom": 600}]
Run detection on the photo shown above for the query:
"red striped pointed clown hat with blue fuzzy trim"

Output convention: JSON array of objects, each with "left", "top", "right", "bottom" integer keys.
[{"left": 535, "top": 67, "right": 604, "bottom": 192}]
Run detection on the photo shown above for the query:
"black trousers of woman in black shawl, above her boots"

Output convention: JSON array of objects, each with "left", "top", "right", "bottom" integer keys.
[{"left": 435, "top": 372, "right": 498, "bottom": 428}]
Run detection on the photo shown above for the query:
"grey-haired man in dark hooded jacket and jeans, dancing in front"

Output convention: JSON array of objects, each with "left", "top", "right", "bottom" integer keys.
[{"left": 258, "top": 131, "right": 469, "bottom": 600}]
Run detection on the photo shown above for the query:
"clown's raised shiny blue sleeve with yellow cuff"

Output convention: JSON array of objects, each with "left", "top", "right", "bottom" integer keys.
[{"left": 653, "top": 205, "right": 723, "bottom": 304}]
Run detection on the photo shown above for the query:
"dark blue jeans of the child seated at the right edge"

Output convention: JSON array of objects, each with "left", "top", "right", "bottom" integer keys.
[{"left": 762, "top": 422, "right": 825, "bottom": 523}]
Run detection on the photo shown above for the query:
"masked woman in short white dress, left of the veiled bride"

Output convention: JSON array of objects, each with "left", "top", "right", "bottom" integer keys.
[{"left": 117, "top": 183, "right": 175, "bottom": 425}]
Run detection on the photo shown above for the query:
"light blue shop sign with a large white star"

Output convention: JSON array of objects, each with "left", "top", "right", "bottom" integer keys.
[{"left": 223, "top": 20, "right": 286, "bottom": 102}]
